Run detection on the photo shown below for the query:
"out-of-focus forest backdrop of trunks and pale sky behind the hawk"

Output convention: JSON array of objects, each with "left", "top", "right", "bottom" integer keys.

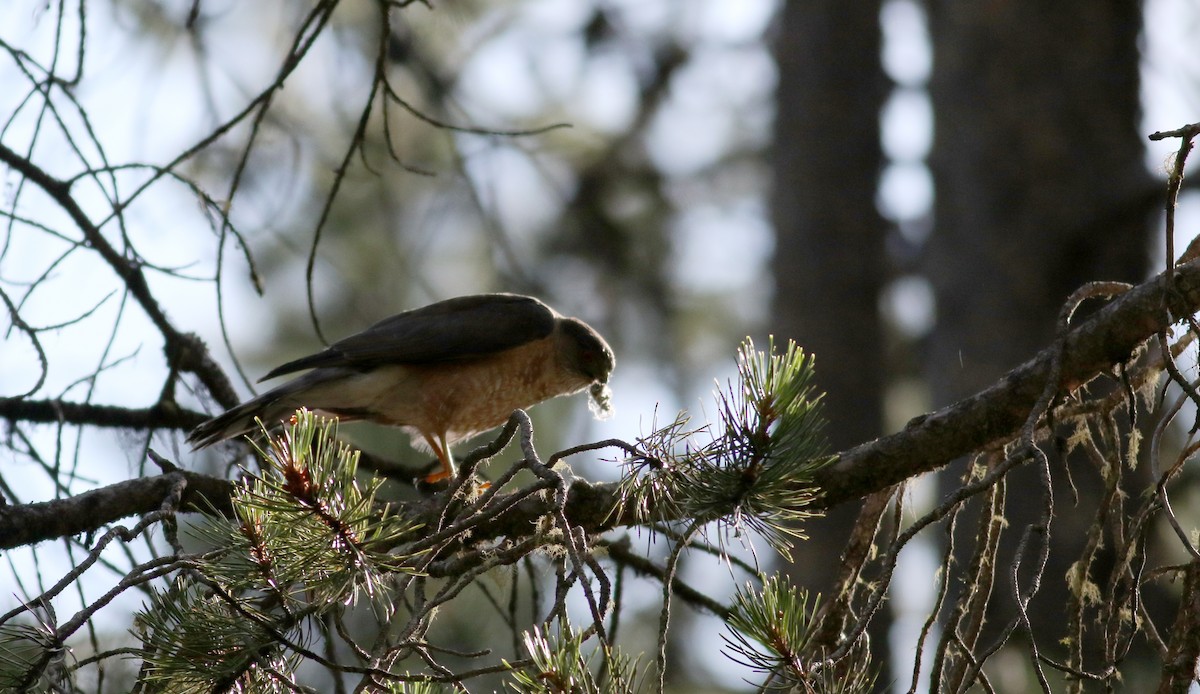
[{"left": 0, "top": 0, "right": 1198, "bottom": 688}]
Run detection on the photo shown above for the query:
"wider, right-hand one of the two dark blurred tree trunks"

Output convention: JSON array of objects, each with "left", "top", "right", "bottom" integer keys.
[{"left": 926, "top": 0, "right": 1159, "bottom": 662}]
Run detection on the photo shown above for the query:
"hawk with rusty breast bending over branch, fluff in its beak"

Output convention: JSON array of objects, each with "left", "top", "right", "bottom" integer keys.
[{"left": 187, "top": 289, "right": 616, "bottom": 480}]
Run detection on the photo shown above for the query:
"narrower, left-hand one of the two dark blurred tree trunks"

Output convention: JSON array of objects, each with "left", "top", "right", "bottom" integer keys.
[{"left": 769, "top": 0, "right": 890, "bottom": 683}]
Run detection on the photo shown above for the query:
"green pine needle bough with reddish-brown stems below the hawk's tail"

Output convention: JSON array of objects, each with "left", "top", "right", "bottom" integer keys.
[{"left": 137, "top": 411, "right": 413, "bottom": 692}]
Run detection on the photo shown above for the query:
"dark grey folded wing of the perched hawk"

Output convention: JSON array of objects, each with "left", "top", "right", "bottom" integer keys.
[{"left": 259, "top": 294, "right": 557, "bottom": 381}]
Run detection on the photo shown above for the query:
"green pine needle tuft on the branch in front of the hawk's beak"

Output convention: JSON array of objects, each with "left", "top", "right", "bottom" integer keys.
[{"left": 622, "top": 337, "right": 833, "bottom": 558}]
